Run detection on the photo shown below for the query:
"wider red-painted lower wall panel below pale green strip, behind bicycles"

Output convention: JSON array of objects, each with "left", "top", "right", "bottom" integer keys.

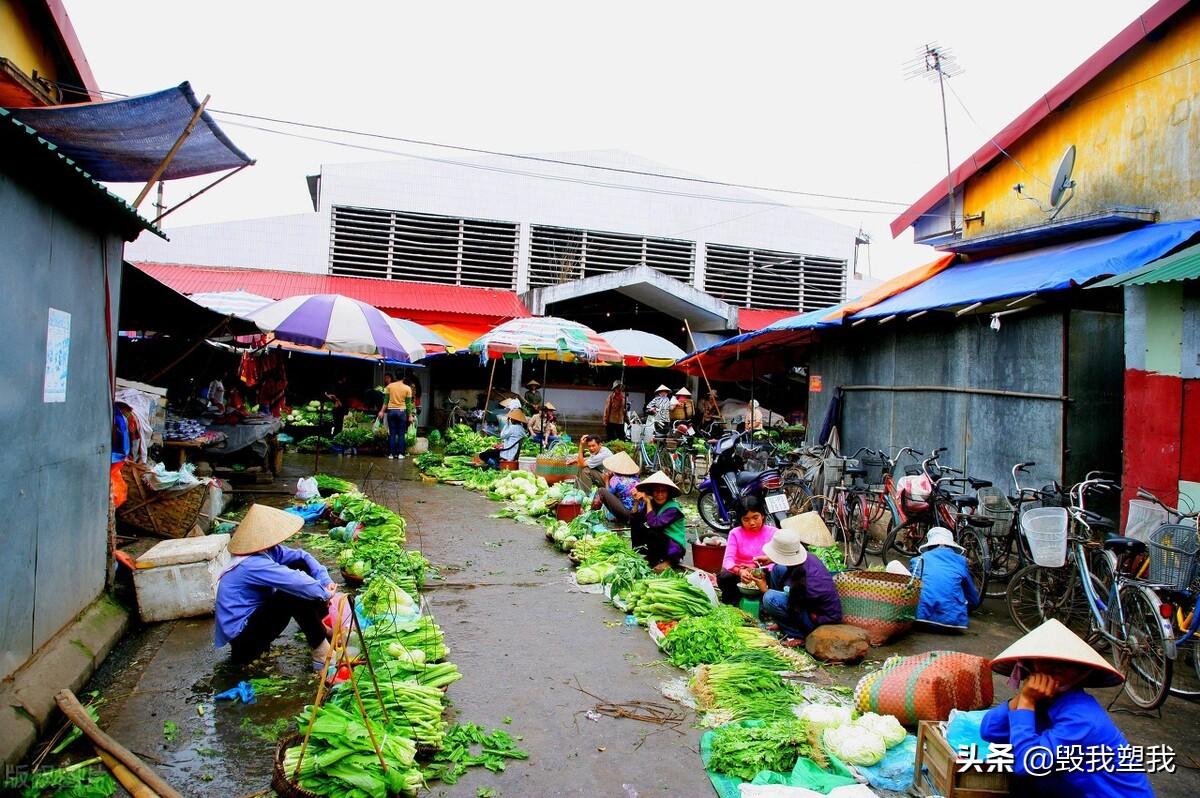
[{"left": 1122, "top": 368, "right": 1185, "bottom": 516}]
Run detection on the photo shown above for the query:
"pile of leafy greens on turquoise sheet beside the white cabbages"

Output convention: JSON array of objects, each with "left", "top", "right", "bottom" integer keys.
[{"left": 708, "top": 718, "right": 821, "bottom": 781}]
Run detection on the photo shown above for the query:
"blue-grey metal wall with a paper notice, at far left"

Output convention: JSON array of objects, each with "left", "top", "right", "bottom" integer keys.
[{"left": 0, "top": 175, "right": 121, "bottom": 677}]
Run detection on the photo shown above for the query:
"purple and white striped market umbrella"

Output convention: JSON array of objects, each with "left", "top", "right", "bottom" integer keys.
[{"left": 246, "top": 294, "right": 426, "bottom": 362}]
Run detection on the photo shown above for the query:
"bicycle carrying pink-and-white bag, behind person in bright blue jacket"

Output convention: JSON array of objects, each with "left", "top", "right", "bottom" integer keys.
[{"left": 882, "top": 446, "right": 991, "bottom": 598}]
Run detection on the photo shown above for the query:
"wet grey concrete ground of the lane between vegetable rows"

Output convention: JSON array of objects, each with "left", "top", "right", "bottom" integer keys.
[{"left": 39, "top": 456, "right": 1200, "bottom": 798}]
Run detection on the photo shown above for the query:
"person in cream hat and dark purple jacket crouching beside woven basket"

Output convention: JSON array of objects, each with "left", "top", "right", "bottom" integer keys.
[{"left": 742, "top": 528, "right": 841, "bottom": 646}]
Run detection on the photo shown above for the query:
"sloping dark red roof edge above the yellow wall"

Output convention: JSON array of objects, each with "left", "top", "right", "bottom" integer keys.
[{"left": 892, "top": 0, "right": 1188, "bottom": 238}]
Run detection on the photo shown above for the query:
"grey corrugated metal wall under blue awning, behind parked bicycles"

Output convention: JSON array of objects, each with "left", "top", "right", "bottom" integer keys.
[{"left": 809, "top": 311, "right": 1122, "bottom": 488}]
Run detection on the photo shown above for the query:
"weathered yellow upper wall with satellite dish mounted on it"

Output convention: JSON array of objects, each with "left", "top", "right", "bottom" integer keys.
[{"left": 964, "top": 5, "right": 1200, "bottom": 238}]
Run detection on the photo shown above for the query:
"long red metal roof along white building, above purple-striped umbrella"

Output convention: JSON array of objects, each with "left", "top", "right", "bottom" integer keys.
[{"left": 133, "top": 262, "right": 529, "bottom": 323}]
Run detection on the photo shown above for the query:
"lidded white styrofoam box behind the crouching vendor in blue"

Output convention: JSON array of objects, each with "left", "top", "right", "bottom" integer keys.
[{"left": 133, "top": 535, "right": 229, "bottom": 622}]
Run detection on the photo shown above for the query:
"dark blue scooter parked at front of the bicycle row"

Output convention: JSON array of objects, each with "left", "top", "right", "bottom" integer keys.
[{"left": 696, "top": 432, "right": 790, "bottom": 532}]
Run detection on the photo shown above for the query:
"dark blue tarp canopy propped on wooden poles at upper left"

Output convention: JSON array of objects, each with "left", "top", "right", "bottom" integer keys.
[{"left": 4, "top": 80, "right": 253, "bottom": 182}]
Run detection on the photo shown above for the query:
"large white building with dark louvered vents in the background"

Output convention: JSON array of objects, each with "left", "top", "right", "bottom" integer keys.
[{"left": 128, "top": 150, "right": 854, "bottom": 335}]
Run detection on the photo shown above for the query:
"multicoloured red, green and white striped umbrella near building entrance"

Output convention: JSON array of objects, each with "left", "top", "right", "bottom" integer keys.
[{"left": 469, "top": 316, "right": 622, "bottom": 364}]
